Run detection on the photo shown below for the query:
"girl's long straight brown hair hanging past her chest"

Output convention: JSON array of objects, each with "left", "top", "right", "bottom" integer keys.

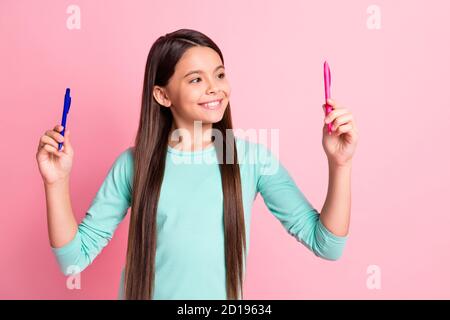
[{"left": 125, "top": 29, "right": 246, "bottom": 300}]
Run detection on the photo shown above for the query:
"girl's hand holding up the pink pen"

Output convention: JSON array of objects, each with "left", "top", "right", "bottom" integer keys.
[{"left": 322, "top": 99, "right": 358, "bottom": 166}]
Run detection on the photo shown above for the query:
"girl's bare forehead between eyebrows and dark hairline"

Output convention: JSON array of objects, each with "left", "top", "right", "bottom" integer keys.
[{"left": 175, "top": 46, "right": 222, "bottom": 75}]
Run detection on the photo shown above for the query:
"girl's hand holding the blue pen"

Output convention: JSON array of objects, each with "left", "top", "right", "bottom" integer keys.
[{"left": 36, "top": 125, "right": 74, "bottom": 185}]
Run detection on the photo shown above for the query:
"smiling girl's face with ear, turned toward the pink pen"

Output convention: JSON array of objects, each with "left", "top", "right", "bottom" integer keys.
[{"left": 154, "top": 47, "right": 231, "bottom": 127}]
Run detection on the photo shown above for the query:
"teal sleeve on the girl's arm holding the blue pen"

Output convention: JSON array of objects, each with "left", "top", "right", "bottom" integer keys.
[{"left": 51, "top": 148, "right": 133, "bottom": 275}]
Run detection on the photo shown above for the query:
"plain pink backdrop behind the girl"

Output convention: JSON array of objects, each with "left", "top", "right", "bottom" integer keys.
[{"left": 0, "top": 0, "right": 450, "bottom": 299}]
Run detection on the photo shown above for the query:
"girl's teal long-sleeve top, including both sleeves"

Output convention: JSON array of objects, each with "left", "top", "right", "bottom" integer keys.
[{"left": 52, "top": 138, "right": 348, "bottom": 300}]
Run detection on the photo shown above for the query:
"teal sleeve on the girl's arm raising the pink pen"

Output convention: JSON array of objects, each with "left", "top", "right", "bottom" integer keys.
[{"left": 257, "top": 143, "right": 348, "bottom": 260}]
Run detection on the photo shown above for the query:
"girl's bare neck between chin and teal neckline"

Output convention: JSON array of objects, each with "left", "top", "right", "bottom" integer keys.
[{"left": 168, "top": 121, "right": 213, "bottom": 151}]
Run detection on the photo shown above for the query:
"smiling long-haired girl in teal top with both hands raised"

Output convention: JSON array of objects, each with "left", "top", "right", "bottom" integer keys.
[{"left": 36, "top": 29, "right": 357, "bottom": 299}]
